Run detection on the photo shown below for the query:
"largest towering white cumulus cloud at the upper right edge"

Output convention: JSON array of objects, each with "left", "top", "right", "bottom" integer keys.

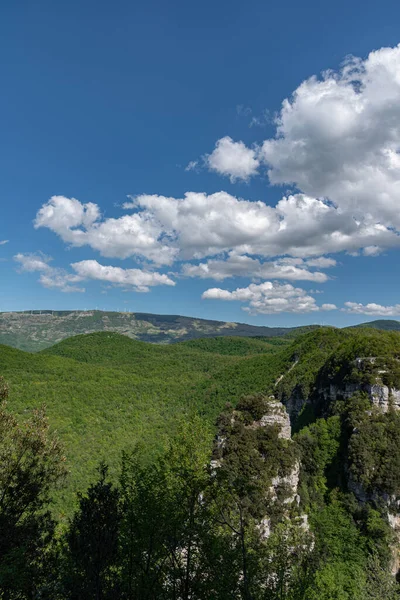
[{"left": 261, "top": 45, "right": 400, "bottom": 228}]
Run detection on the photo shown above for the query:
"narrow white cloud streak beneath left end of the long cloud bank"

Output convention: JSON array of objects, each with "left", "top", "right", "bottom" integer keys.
[{"left": 71, "top": 260, "right": 175, "bottom": 292}]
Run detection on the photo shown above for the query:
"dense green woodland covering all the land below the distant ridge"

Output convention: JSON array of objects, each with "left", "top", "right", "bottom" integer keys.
[{"left": 0, "top": 328, "right": 400, "bottom": 600}]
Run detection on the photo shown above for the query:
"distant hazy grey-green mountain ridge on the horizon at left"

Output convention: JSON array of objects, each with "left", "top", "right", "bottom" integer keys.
[{"left": 0, "top": 310, "right": 319, "bottom": 352}]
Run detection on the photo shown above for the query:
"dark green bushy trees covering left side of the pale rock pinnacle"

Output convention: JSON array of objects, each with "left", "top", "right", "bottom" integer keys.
[{"left": 212, "top": 395, "right": 302, "bottom": 600}]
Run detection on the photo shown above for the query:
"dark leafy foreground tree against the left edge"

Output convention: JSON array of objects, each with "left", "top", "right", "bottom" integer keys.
[{"left": 0, "top": 378, "right": 66, "bottom": 599}]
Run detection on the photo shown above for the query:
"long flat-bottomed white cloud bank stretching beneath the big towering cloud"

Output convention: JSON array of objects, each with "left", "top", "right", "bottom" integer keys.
[{"left": 35, "top": 192, "right": 400, "bottom": 268}]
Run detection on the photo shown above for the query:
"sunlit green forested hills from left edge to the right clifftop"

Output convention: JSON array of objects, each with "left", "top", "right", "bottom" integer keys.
[{"left": 0, "top": 328, "right": 400, "bottom": 507}]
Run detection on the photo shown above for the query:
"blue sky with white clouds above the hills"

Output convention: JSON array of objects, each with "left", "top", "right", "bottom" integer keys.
[{"left": 0, "top": 0, "right": 400, "bottom": 325}]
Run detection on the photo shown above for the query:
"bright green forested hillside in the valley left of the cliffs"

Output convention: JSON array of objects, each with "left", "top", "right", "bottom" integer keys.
[{"left": 0, "top": 333, "right": 288, "bottom": 505}]
